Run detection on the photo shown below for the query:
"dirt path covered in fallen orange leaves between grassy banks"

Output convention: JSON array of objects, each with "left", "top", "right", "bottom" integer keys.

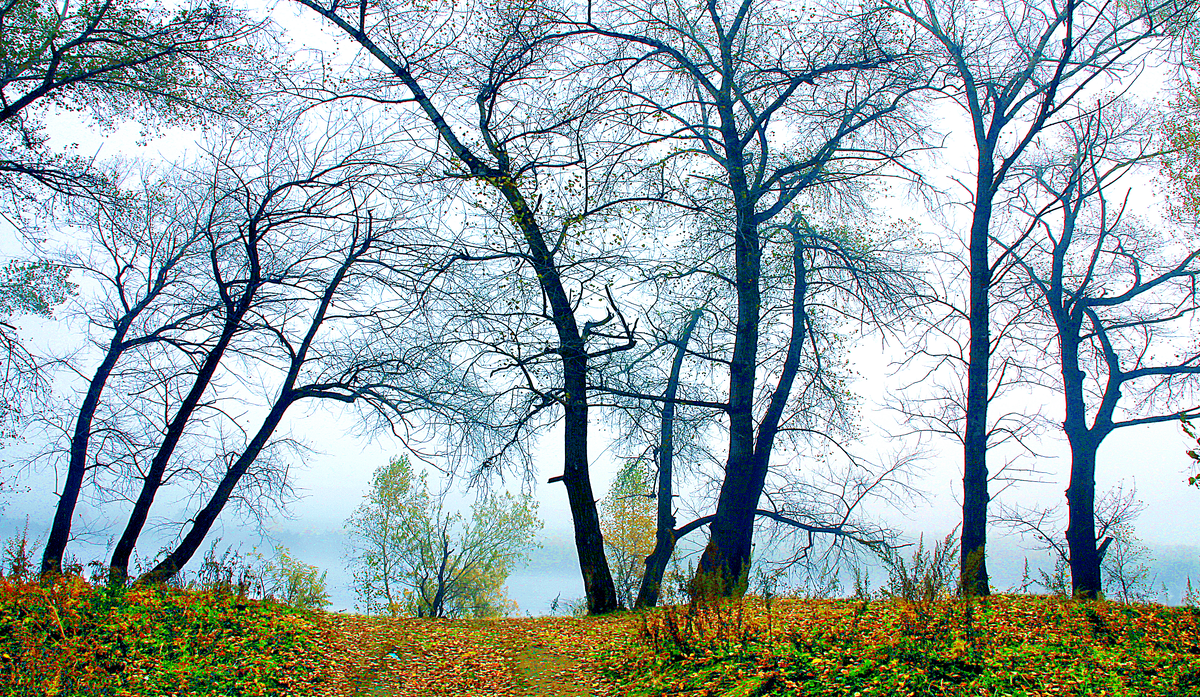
[{"left": 295, "top": 615, "right": 637, "bottom": 697}]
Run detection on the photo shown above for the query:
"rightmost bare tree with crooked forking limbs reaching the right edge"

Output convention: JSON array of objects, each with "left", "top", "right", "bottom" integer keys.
[{"left": 1014, "top": 106, "right": 1200, "bottom": 599}]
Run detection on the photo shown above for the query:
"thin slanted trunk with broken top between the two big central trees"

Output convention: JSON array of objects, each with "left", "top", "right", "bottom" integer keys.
[{"left": 635, "top": 310, "right": 703, "bottom": 608}]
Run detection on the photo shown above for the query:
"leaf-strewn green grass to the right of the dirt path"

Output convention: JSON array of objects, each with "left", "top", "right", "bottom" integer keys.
[{"left": 617, "top": 596, "right": 1200, "bottom": 697}]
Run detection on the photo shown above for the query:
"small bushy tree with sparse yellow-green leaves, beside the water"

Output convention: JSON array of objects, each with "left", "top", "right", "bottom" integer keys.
[{"left": 347, "top": 457, "right": 541, "bottom": 618}]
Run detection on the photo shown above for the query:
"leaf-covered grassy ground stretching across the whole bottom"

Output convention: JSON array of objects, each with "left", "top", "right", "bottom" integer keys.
[{"left": 0, "top": 576, "right": 1200, "bottom": 697}]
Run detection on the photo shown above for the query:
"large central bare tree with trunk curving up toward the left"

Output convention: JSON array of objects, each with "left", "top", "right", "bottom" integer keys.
[{"left": 298, "top": 0, "right": 652, "bottom": 613}]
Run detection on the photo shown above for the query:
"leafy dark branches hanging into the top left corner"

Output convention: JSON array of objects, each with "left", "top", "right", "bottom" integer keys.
[{"left": 0, "top": 0, "right": 266, "bottom": 198}]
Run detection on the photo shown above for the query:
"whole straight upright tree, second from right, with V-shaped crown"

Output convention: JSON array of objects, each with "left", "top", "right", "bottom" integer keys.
[{"left": 878, "top": 0, "right": 1189, "bottom": 595}]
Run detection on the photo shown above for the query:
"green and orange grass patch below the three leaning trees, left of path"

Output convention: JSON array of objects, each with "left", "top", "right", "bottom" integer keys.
[{"left": 0, "top": 576, "right": 319, "bottom": 697}]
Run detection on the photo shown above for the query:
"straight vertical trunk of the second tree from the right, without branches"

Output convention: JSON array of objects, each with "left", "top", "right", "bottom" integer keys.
[{"left": 959, "top": 176, "right": 992, "bottom": 595}]
